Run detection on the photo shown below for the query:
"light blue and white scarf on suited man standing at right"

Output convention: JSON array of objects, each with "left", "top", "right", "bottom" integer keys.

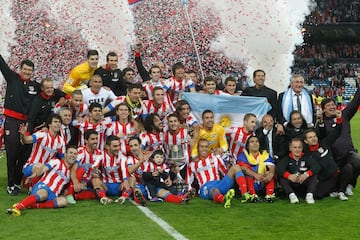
[{"left": 281, "top": 88, "right": 313, "bottom": 123}]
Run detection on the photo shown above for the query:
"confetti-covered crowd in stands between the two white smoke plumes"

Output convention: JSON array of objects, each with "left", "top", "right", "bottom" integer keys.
[{"left": 132, "top": 0, "right": 245, "bottom": 80}]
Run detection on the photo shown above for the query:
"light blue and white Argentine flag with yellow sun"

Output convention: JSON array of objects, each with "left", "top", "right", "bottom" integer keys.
[{"left": 182, "top": 92, "right": 271, "bottom": 129}]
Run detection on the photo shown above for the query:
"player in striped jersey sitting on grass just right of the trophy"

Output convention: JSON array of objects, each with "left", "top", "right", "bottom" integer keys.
[{"left": 187, "top": 139, "right": 246, "bottom": 208}]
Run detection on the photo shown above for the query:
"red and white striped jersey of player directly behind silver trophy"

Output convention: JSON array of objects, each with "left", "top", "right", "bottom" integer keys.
[{"left": 164, "top": 128, "right": 191, "bottom": 166}]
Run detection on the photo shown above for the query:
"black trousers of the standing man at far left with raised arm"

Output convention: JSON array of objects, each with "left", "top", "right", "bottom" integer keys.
[{"left": 4, "top": 116, "right": 32, "bottom": 187}]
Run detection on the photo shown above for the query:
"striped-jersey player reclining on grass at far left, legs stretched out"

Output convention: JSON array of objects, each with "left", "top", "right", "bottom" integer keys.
[{"left": 7, "top": 146, "right": 78, "bottom": 216}]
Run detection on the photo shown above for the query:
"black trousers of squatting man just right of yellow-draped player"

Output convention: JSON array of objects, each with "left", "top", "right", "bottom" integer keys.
[{"left": 280, "top": 175, "right": 317, "bottom": 196}]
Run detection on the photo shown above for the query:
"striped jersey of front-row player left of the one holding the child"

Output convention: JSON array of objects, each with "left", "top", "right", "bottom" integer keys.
[{"left": 101, "top": 151, "right": 130, "bottom": 183}]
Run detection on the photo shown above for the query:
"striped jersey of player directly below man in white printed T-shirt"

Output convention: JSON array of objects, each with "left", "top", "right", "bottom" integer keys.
[{"left": 72, "top": 117, "right": 112, "bottom": 149}]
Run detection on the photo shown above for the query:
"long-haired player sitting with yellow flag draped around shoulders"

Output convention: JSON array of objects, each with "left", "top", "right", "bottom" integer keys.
[{"left": 236, "top": 136, "right": 275, "bottom": 203}]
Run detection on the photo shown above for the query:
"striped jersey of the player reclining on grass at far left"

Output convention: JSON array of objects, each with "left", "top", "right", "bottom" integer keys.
[{"left": 39, "top": 158, "right": 70, "bottom": 196}]
